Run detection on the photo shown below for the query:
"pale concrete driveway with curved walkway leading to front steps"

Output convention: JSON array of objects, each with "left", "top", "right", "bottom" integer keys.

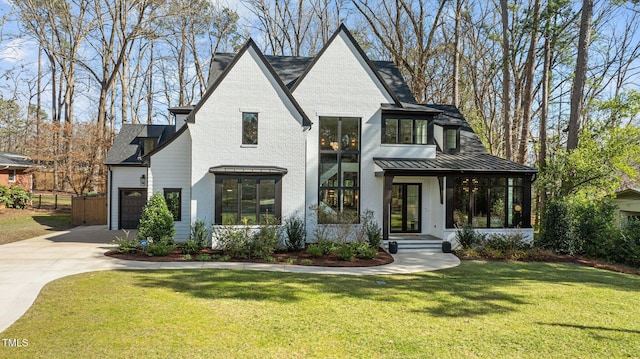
[{"left": 0, "top": 226, "right": 460, "bottom": 332}]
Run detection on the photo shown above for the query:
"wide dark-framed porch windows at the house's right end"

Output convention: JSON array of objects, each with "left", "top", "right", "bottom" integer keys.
[{"left": 453, "top": 177, "right": 524, "bottom": 228}]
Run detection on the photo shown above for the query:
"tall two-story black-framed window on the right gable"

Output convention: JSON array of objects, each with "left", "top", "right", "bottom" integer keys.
[{"left": 318, "top": 117, "right": 360, "bottom": 223}]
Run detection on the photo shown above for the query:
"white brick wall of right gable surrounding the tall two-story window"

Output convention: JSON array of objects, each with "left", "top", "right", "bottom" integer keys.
[{"left": 293, "top": 32, "right": 435, "bottom": 238}]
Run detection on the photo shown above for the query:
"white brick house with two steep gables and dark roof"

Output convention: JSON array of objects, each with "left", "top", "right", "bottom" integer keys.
[{"left": 107, "top": 26, "right": 536, "bottom": 250}]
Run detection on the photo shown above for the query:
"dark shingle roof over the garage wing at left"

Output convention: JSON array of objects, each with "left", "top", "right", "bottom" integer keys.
[{"left": 104, "top": 124, "right": 176, "bottom": 166}]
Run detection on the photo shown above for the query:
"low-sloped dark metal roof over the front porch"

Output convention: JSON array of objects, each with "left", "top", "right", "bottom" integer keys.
[{"left": 373, "top": 153, "right": 538, "bottom": 174}]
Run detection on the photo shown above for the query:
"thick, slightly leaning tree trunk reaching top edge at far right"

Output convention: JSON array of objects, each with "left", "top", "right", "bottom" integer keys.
[{"left": 567, "top": 0, "right": 593, "bottom": 151}]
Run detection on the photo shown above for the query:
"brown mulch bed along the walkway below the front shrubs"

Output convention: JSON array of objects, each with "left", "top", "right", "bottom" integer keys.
[{"left": 105, "top": 249, "right": 393, "bottom": 267}]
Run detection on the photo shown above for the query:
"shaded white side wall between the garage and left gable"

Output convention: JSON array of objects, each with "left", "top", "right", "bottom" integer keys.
[{"left": 147, "top": 129, "right": 191, "bottom": 241}]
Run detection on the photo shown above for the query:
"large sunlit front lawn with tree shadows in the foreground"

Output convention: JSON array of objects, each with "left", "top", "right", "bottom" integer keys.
[{"left": 0, "top": 262, "right": 640, "bottom": 358}]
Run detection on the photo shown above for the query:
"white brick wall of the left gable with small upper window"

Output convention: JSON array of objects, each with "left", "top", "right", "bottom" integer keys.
[{"left": 189, "top": 47, "right": 306, "bottom": 222}]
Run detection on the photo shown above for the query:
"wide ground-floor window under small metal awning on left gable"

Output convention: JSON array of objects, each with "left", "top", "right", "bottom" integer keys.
[{"left": 215, "top": 175, "right": 282, "bottom": 225}]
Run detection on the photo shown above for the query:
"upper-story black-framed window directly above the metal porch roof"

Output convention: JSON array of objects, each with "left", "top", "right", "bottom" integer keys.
[{"left": 382, "top": 115, "right": 429, "bottom": 145}]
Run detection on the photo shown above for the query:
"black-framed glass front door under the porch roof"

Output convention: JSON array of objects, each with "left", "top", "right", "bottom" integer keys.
[{"left": 391, "top": 183, "right": 422, "bottom": 233}]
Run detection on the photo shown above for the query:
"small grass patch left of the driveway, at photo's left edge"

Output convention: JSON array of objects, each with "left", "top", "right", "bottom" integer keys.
[{"left": 0, "top": 209, "right": 72, "bottom": 246}]
